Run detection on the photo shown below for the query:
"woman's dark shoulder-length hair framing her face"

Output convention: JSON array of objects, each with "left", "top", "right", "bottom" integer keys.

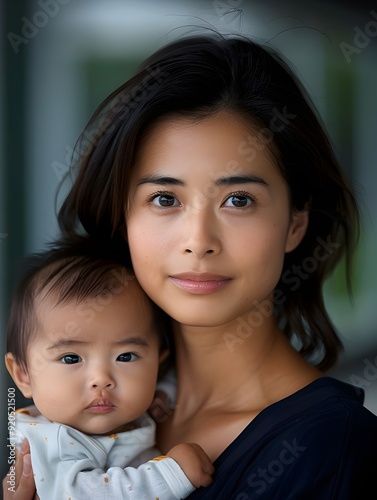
[{"left": 59, "top": 34, "right": 359, "bottom": 370}]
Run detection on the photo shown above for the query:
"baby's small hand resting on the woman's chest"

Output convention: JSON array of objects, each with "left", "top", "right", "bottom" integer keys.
[{"left": 167, "top": 443, "right": 215, "bottom": 488}]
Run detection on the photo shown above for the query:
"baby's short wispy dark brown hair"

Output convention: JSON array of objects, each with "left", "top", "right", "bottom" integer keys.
[{"left": 6, "top": 238, "right": 170, "bottom": 369}]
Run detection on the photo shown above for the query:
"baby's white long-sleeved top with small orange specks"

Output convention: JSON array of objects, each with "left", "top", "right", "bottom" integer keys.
[{"left": 16, "top": 422, "right": 195, "bottom": 500}]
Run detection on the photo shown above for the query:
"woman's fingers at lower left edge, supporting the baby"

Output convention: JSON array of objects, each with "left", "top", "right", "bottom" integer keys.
[{"left": 3, "top": 439, "right": 39, "bottom": 500}]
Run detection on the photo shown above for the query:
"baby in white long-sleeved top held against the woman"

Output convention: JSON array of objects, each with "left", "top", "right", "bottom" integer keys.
[{"left": 6, "top": 242, "right": 214, "bottom": 500}]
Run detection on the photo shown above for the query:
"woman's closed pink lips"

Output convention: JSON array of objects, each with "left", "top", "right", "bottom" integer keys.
[{"left": 169, "top": 273, "right": 231, "bottom": 295}]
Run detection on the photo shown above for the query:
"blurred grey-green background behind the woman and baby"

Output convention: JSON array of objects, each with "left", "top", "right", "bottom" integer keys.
[{"left": 0, "top": 0, "right": 377, "bottom": 484}]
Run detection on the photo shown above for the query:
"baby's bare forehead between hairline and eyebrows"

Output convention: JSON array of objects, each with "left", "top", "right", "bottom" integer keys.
[{"left": 34, "top": 277, "right": 160, "bottom": 345}]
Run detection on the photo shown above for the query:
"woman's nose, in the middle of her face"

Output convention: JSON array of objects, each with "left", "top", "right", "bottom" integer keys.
[{"left": 181, "top": 210, "right": 221, "bottom": 259}]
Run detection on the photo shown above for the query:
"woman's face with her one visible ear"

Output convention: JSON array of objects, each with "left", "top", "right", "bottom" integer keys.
[{"left": 127, "top": 113, "right": 307, "bottom": 326}]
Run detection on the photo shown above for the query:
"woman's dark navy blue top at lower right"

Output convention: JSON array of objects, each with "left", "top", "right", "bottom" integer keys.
[{"left": 189, "top": 377, "right": 377, "bottom": 500}]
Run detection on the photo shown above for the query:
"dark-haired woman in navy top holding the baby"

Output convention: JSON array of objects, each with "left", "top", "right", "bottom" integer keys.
[{"left": 3, "top": 36, "right": 377, "bottom": 500}]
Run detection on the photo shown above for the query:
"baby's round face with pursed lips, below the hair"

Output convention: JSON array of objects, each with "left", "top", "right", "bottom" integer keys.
[{"left": 23, "top": 277, "right": 160, "bottom": 434}]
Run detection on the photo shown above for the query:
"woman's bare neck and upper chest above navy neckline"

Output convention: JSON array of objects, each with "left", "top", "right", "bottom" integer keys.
[{"left": 157, "top": 318, "right": 321, "bottom": 460}]
